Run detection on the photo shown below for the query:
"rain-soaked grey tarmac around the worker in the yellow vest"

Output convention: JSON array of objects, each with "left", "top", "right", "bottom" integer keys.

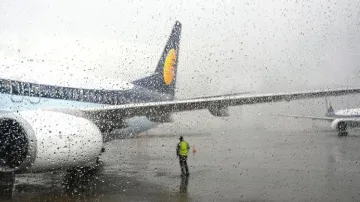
[{"left": 2, "top": 128, "right": 360, "bottom": 201}]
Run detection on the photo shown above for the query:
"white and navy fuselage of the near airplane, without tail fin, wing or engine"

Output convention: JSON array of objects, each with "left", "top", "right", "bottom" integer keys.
[{"left": 0, "top": 62, "right": 169, "bottom": 140}]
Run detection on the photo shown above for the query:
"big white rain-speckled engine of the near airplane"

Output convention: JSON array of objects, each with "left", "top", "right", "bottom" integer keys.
[{"left": 0, "top": 110, "right": 103, "bottom": 172}]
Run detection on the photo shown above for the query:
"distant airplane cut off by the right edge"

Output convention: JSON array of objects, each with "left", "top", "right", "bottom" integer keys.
[{"left": 277, "top": 98, "right": 360, "bottom": 136}]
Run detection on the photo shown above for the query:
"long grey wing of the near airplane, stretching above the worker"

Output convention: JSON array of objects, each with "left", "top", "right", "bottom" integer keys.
[{"left": 80, "top": 88, "right": 360, "bottom": 118}]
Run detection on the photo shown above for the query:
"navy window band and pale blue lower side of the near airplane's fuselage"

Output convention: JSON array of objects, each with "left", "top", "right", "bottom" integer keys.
[{"left": 0, "top": 79, "right": 173, "bottom": 111}]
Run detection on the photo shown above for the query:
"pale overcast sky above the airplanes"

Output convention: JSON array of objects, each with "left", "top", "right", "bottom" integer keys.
[{"left": 0, "top": 0, "right": 360, "bottom": 97}]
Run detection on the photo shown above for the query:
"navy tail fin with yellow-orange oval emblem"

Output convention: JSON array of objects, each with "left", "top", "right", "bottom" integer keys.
[{"left": 133, "top": 21, "right": 181, "bottom": 95}]
